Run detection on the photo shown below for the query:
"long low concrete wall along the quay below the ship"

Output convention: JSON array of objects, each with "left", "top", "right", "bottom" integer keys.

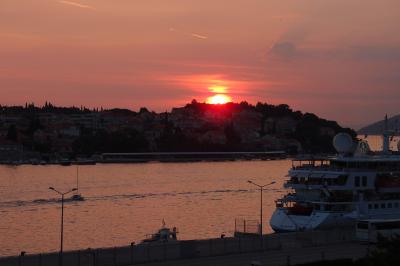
[{"left": 0, "top": 230, "right": 355, "bottom": 266}]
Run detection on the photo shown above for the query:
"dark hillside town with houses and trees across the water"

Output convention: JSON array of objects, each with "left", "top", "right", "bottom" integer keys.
[{"left": 0, "top": 100, "right": 356, "bottom": 163}]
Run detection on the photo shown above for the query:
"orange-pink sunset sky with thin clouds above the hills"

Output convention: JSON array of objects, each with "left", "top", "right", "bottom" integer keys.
[{"left": 0, "top": 0, "right": 400, "bottom": 128}]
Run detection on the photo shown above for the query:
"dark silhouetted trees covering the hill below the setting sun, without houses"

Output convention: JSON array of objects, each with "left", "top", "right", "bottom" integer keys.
[{"left": 0, "top": 100, "right": 356, "bottom": 156}]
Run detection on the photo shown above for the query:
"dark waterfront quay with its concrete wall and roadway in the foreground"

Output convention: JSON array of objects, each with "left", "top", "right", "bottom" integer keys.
[{"left": 0, "top": 230, "right": 369, "bottom": 266}]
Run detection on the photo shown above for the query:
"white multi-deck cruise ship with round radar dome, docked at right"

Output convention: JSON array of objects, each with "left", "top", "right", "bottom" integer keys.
[{"left": 270, "top": 118, "right": 400, "bottom": 232}]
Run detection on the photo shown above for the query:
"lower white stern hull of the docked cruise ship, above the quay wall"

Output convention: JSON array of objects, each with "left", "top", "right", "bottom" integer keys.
[{"left": 270, "top": 208, "right": 356, "bottom": 233}]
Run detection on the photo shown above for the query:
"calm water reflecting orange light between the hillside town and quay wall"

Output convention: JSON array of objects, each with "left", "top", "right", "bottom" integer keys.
[{"left": 0, "top": 160, "right": 290, "bottom": 256}]
